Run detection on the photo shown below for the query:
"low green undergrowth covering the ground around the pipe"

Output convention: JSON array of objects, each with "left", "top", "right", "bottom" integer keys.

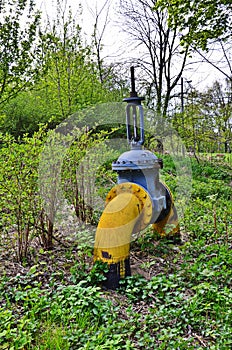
[{"left": 0, "top": 159, "right": 232, "bottom": 350}]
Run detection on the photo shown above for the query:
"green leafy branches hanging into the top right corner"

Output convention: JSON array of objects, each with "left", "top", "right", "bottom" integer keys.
[{"left": 156, "top": 0, "right": 232, "bottom": 50}]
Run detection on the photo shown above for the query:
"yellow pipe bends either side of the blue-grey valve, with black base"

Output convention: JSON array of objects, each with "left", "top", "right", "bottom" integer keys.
[{"left": 94, "top": 182, "right": 179, "bottom": 289}]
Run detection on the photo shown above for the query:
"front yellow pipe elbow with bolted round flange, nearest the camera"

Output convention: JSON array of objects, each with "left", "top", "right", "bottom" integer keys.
[{"left": 94, "top": 182, "right": 152, "bottom": 264}]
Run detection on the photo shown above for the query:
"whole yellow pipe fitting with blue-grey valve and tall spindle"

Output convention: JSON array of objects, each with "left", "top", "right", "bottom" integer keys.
[{"left": 94, "top": 67, "right": 180, "bottom": 289}]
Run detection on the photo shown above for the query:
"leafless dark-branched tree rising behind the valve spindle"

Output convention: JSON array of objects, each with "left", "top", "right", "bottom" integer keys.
[{"left": 120, "top": 0, "right": 188, "bottom": 116}]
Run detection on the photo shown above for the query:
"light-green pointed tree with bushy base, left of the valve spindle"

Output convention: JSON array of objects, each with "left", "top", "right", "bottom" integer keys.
[{"left": 0, "top": 0, "right": 127, "bottom": 138}]
